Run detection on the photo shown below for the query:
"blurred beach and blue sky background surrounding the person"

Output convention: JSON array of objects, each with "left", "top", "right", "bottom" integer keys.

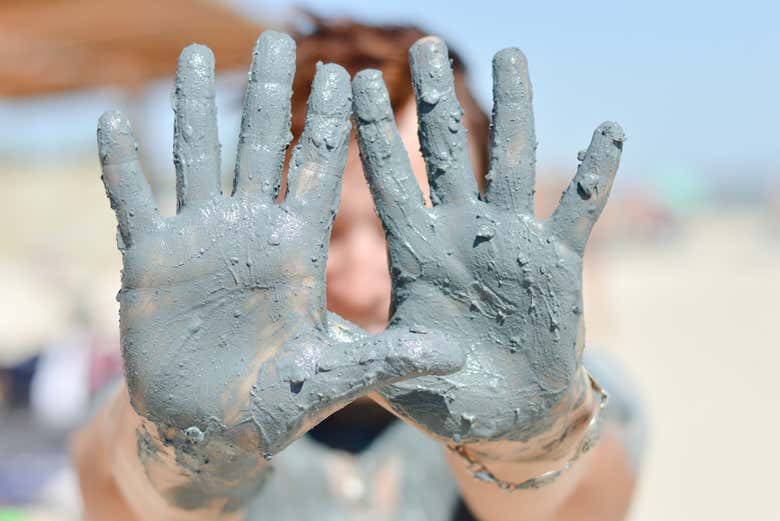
[{"left": 0, "top": 0, "right": 780, "bottom": 521}]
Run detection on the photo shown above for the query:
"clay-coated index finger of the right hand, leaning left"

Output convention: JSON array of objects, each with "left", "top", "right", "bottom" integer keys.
[{"left": 352, "top": 70, "right": 426, "bottom": 236}]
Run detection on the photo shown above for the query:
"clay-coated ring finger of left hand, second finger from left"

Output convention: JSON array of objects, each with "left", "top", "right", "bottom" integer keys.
[{"left": 173, "top": 44, "right": 220, "bottom": 209}]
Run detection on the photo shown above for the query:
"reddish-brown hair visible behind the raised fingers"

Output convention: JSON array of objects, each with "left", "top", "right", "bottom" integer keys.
[{"left": 292, "top": 12, "right": 490, "bottom": 185}]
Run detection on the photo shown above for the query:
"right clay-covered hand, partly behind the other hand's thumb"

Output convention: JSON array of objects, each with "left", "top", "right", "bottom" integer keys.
[{"left": 353, "top": 37, "right": 625, "bottom": 442}]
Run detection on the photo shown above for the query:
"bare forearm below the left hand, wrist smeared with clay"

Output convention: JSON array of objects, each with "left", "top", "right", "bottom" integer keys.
[{"left": 73, "top": 385, "right": 266, "bottom": 521}]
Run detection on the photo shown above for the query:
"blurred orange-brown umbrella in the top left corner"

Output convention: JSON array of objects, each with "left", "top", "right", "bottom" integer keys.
[{"left": 0, "top": 0, "right": 262, "bottom": 97}]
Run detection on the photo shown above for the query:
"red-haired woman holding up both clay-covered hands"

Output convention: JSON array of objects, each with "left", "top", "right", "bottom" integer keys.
[{"left": 74, "top": 16, "right": 636, "bottom": 521}]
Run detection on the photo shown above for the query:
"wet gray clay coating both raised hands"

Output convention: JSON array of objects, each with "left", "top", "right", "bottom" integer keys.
[{"left": 98, "top": 27, "right": 624, "bottom": 510}]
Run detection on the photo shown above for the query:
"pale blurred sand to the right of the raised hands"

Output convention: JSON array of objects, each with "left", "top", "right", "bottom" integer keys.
[{"left": 585, "top": 210, "right": 780, "bottom": 521}]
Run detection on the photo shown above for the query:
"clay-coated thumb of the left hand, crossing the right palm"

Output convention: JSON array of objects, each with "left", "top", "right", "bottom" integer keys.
[{"left": 252, "top": 330, "right": 465, "bottom": 454}]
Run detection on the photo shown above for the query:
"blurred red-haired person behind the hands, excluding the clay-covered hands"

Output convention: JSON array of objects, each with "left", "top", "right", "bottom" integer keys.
[{"left": 73, "top": 18, "right": 641, "bottom": 521}]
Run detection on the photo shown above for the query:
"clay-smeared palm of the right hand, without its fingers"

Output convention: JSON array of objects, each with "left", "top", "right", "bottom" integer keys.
[{"left": 382, "top": 201, "right": 582, "bottom": 439}]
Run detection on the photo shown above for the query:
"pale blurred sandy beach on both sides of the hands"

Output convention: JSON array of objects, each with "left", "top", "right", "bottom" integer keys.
[{"left": 0, "top": 164, "right": 780, "bottom": 521}]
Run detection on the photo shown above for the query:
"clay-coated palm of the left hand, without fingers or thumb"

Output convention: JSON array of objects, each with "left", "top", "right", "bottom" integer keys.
[{"left": 120, "top": 196, "right": 325, "bottom": 425}]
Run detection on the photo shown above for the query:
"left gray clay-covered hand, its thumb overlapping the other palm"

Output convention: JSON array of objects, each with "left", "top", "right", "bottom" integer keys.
[{"left": 98, "top": 31, "right": 463, "bottom": 463}]
